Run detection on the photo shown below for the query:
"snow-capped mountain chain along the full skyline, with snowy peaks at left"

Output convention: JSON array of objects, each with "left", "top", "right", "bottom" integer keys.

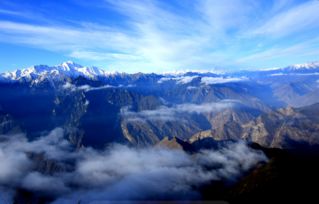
[{"left": 0, "top": 61, "right": 319, "bottom": 84}]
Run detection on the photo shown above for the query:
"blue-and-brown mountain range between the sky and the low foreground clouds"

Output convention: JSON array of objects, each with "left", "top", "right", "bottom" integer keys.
[{"left": 0, "top": 62, "right": 319, "bottom": 148}]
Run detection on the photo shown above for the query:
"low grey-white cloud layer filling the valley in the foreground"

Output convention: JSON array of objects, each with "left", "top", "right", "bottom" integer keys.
[{"left": 0, "top": 128, "right": 267, "bottom": 203}]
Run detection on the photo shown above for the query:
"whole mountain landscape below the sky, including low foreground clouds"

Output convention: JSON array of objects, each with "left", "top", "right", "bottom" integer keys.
[{"left": 0, "top": 62, "right": 319, "bottom": 203}]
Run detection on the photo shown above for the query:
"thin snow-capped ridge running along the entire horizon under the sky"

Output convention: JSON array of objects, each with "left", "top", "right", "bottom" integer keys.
[{"left": 0, "top": 61, "right": 319, "bottom": 81}]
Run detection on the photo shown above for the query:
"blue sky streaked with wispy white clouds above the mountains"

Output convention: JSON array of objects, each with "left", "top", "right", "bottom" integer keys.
[{"left": 0, "top": 0, "right": 319, "bottom": 72}]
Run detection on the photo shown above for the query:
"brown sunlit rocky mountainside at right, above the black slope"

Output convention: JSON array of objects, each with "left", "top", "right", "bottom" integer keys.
[{"left": 190, "top": 103, "right": 319, "bottom": 148}]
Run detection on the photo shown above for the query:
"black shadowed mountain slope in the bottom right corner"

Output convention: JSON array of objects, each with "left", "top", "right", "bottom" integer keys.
[{"left": 226, "top": 145, "right": 319, "bottom": 203}]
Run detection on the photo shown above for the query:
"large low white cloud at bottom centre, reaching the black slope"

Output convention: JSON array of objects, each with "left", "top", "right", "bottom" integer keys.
[{"left": 55, "top": 143, "right": 267, "bottom": 203}]
